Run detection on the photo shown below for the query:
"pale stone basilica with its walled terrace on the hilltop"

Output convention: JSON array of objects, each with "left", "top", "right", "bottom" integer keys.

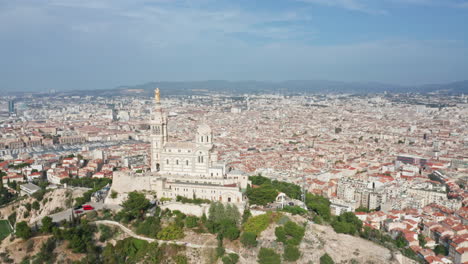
[{"left": 107, "top": 89, "right": 249, "bottom": 204}]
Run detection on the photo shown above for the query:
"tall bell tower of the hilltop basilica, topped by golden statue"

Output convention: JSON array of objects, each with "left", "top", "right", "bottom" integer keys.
[{"left": 149, "top": 88, "right": 168, "bottom": 172}]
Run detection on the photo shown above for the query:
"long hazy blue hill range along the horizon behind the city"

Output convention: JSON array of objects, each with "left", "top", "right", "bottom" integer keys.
[{"left": 11, "top": 80, "right": 468, "bottom": 96}]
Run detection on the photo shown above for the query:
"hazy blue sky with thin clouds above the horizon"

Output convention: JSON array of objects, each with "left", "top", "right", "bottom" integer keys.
[{"left": 0, "top": 0, "right": 468, "bottom": 91}]
